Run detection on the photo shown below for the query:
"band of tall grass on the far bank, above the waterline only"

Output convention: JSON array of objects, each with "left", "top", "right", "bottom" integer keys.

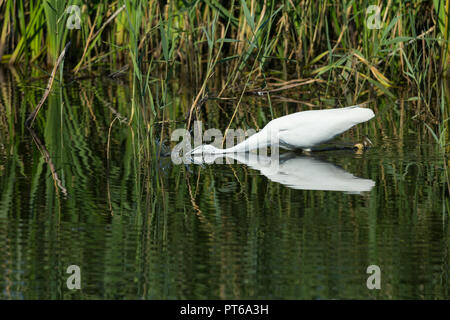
[{"left": 0, "top": 0, "right": 449, "bottom": 77}]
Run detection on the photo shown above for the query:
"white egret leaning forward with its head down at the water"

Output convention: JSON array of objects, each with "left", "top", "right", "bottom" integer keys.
[{"left": 190, "top": 105, "right": 375, "bottom": 155}]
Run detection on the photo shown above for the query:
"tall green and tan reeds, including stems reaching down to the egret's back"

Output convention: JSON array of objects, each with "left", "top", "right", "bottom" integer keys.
[{"left": 0, "top": 0, "right": 450, "bottom": 154}]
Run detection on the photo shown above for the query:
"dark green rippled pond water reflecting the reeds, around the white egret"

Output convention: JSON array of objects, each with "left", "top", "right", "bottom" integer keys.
[{"left": 0, "top": 70, "right": 450, "bottom": 299}]
